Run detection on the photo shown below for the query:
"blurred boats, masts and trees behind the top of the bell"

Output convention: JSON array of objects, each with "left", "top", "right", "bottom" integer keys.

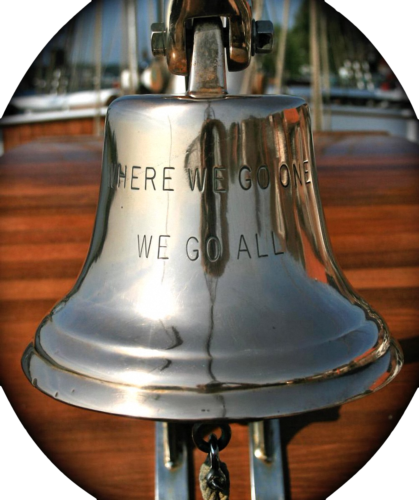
[{"left": 0, "top": 0, "right": 419, "bottom": 154}]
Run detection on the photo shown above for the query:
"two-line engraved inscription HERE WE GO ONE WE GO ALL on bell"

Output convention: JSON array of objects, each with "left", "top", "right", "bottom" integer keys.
[{"left": 120, "top": 159, "right": 312, "bottom": 265}]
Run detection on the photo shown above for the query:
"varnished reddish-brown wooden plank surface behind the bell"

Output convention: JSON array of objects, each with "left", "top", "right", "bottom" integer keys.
[{"left": 0, "top": 133, "right": 419, "bottom": 500}]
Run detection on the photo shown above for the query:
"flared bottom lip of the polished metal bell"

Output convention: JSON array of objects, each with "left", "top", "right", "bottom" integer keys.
[{"left": 22, "top": 339, "right": 403, "bottom": 421}]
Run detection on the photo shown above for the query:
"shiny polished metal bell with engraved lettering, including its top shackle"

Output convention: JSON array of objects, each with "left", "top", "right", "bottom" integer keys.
[{"left": 22, "top": 1, "right": 402, "bottom": 496}]
